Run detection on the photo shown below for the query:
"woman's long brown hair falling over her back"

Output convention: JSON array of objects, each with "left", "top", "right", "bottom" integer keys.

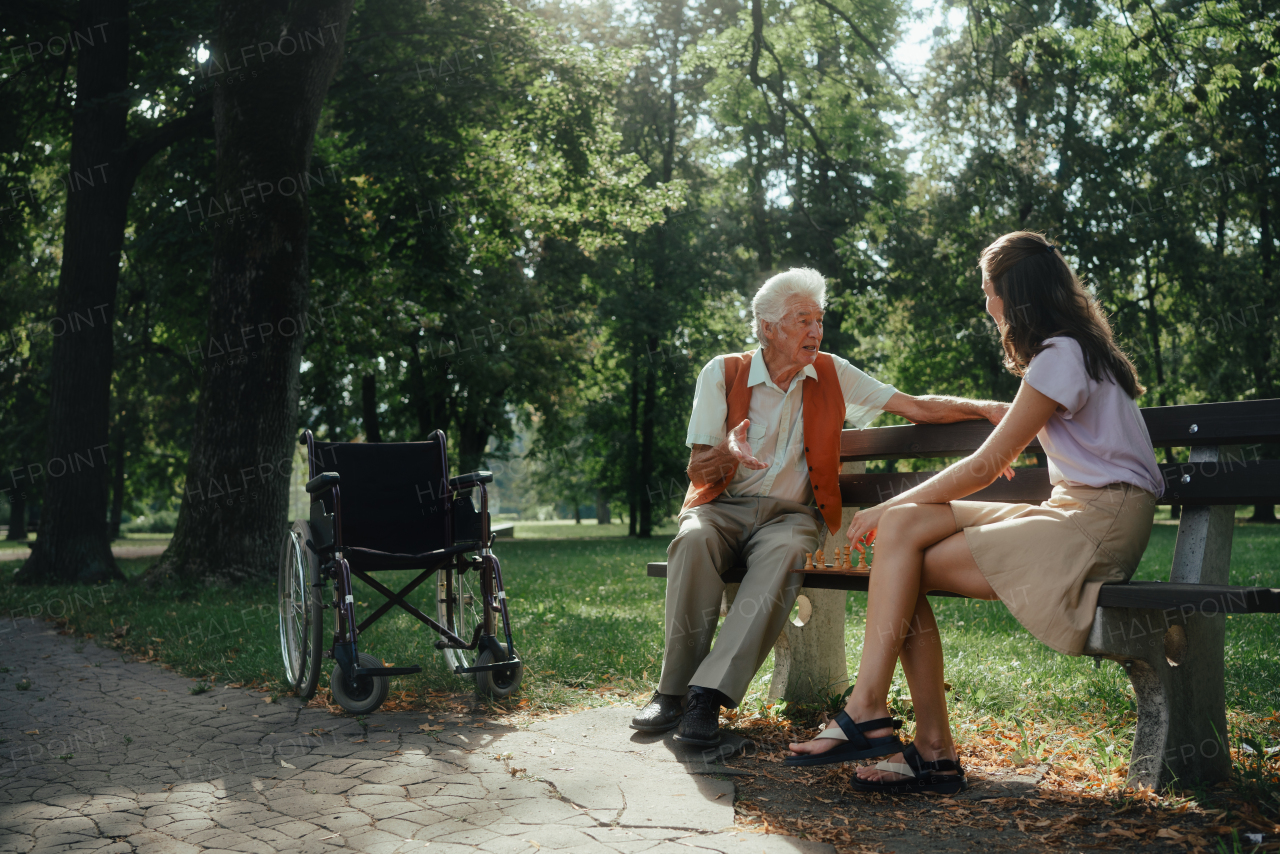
[{"left": 978, "top": 232, "right": 1147, "bottom": 398}]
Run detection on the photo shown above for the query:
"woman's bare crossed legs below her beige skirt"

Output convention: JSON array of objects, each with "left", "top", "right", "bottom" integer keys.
[{"left": 791, "top": 504, "right": 996, "bottom": 775}]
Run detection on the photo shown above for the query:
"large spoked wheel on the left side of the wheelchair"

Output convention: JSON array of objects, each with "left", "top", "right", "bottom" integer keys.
[{"left": 276, "top": 520, "right": 324, "bottom": 700}]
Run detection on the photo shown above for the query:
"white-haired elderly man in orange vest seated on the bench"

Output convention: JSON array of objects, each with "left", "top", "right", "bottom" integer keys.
[{"left": 631, "top": 268, "right": 1007, "bottom": 746}]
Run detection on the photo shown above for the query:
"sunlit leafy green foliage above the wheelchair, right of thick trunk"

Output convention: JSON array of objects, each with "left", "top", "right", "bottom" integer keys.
[{"left": 294, "top": 1, "right": 672, "bottom": 481}]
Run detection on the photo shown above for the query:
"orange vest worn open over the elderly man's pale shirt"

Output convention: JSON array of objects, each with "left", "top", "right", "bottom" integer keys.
[{"left": 681, "top": 352, "right": 845, "bottom": 533}]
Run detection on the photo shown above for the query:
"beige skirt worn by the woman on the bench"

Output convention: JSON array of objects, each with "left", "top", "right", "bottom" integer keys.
[{"left": 951, "top": 483, "right": 1156, "bottom": 656}]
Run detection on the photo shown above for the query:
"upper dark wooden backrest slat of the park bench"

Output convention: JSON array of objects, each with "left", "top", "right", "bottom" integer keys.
[{"left": 840, "top": 399, "right": 1280, "bottom": 462}]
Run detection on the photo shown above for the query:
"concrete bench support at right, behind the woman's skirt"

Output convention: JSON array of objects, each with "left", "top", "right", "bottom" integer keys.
[{"left": 1085, "top": 446, "right": 1235, "bottom": 790}]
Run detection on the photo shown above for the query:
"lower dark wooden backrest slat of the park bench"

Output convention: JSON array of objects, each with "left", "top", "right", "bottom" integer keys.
[{"left": 840, "top": 457, "right": 1280, "bottom": 507}]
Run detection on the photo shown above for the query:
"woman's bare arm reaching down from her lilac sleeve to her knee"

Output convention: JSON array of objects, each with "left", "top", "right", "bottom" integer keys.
[{"left": 849, "top": 382, "right": 1059, "bottom": 543}]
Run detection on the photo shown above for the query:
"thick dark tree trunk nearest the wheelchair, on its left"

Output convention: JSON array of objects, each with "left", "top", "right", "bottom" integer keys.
[{"left": 147, "top": 0, "right": 353, "bottom": 585}]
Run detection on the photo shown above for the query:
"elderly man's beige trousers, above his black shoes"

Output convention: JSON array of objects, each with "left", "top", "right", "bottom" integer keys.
[{"left": 658, "top": 495, "right": 826, "bottom": 705}]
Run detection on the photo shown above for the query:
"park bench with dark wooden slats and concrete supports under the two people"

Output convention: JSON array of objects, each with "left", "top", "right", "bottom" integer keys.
[{"left": 649, "top": 399, "right": 1280, "bottom": 789}]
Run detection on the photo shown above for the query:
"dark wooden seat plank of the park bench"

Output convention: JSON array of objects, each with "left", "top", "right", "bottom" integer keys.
[{"left": 648, "top": 562, "right": 1280, "bottom": 616}]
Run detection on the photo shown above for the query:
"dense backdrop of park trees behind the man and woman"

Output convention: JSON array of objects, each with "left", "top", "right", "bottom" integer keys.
[{"left": 0, "top": 0, "right": 1280, "bottom": 583}]
